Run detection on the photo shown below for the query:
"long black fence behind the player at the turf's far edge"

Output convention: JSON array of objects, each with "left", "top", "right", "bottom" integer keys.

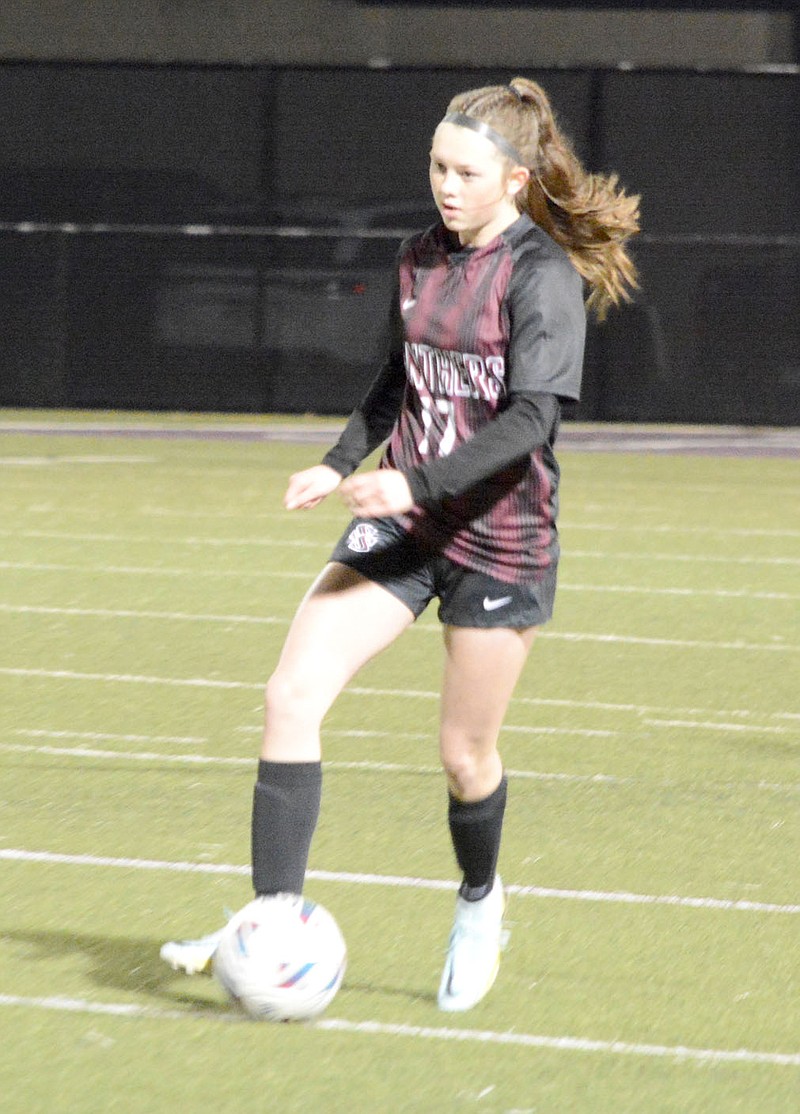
[{"left": 0, "top": 63, "right": 800, "bottom": 424}]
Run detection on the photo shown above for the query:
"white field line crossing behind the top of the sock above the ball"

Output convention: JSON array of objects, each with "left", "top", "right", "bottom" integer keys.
[{"left": 7, "top": 732, "right": 800, "bottom": 793}]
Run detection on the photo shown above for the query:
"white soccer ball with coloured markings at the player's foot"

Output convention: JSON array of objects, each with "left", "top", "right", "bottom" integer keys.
[{"left": 214, "top": 893, "right": 347, "bottom": 1022}]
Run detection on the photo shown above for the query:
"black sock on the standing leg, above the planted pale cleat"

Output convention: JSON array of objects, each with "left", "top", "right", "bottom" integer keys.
[{"left": 448, "top": 774, "right": 508, "bottom": 901}]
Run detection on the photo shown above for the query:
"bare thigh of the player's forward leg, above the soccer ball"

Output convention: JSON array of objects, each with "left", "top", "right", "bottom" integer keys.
[{"left": 267, "top": 563, "right": 414, "bottom": 705}]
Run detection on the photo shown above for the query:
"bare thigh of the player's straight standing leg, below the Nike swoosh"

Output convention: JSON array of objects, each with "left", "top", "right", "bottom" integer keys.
[{"left": 440, "top": 626, "right": 537, "bottom": 764}]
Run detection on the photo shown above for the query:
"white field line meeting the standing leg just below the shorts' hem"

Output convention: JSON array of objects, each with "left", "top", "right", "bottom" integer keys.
[{"left": 0, "top": 604, "right": 800, "bottom": 654}]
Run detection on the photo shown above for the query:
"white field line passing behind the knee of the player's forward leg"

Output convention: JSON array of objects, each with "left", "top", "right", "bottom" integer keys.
[{"left": 0, "top": 666, "right": 800, "bottom": 722}]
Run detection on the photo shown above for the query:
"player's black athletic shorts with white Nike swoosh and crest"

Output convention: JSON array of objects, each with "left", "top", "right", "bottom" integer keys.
[{"left": 331, "top": 518, "right": 556, "bottom": 629}]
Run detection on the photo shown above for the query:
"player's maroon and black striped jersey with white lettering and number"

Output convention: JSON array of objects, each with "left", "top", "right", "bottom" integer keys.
[{"left": 325, "top": 215, "right": 586, "bottom": 583}]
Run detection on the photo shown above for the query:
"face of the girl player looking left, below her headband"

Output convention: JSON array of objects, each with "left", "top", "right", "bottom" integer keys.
[{"left": 430, "top": 124, "right": 528, "bottom": 247}]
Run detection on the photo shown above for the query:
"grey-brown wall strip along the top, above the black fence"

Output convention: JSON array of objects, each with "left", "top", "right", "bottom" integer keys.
[{"left": 0, "top": 0, "right": 796, "bottom": 68}]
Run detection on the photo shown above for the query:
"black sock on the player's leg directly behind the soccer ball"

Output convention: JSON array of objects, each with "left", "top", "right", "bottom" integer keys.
[{"left": 251, "top": 759, "right": 322, "bottom": 896}]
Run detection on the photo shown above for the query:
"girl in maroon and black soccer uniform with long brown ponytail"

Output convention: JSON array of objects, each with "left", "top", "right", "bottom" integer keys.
[{"left": 162, "top": 78, "right": 638, "bottom": 1010}]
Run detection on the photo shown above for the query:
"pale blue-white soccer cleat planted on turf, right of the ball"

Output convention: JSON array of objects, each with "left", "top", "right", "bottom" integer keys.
[{"left": 439, "top": 877, "right": 506, "bottom": 1013}]
